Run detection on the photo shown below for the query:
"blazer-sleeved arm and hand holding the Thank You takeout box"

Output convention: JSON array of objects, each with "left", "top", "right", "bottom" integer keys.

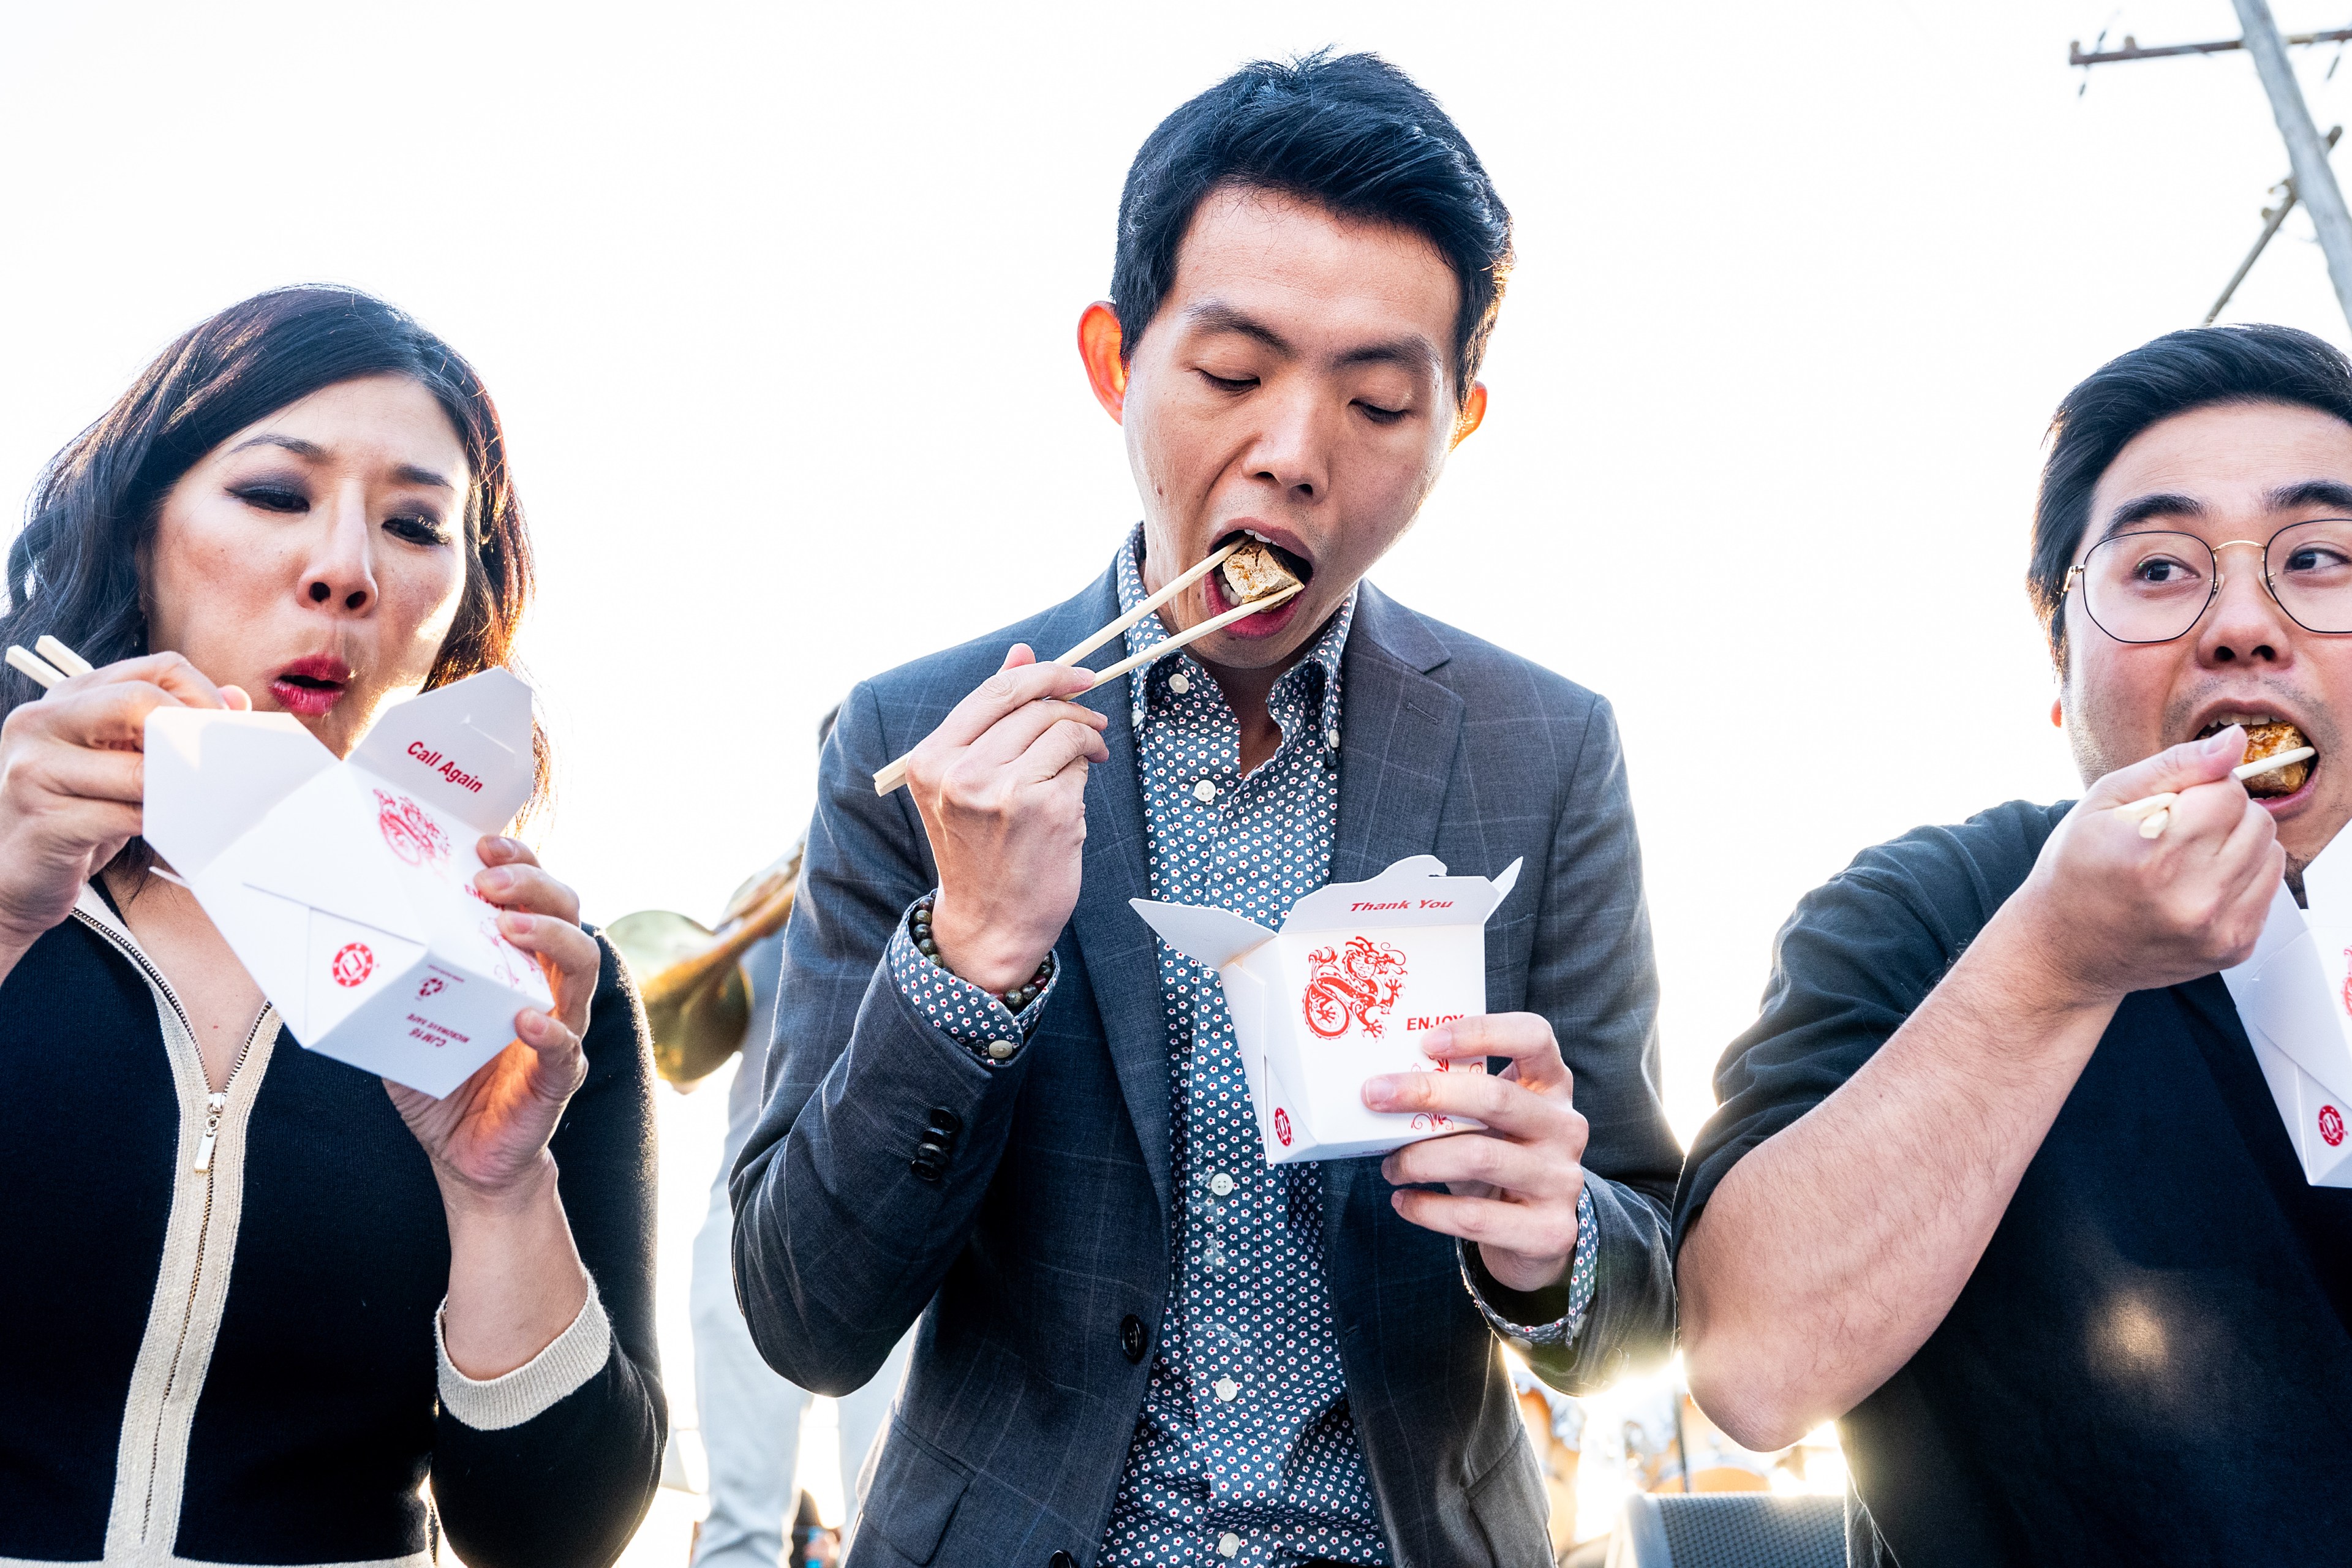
[{"left": 1366, "top": 698, "right": 1682, "bottom": 1392}]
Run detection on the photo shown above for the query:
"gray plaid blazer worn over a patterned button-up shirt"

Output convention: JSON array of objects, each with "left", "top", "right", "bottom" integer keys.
[{"left": 731, "top": 573, "right": 1682, "bottom": 1568}]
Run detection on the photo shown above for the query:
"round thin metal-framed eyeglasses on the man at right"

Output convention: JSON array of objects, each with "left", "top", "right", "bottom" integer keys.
[{"left": 2065, "top": 517, "right": 2352, "bottom": 642}]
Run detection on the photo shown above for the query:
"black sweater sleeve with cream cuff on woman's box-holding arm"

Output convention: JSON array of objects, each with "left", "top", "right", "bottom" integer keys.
[{"left": 433, "top": 936, "right": 668, "bottom": 1568}]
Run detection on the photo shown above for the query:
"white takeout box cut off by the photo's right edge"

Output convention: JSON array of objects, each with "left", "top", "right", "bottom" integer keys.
[{"left": 2220, "top": 835, "right": 2352, "bottom": 1187}]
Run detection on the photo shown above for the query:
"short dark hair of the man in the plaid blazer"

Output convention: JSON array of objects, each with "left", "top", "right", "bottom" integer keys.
[{"left": 1110, "top": 50, "right": 1510, "bottom": 411}]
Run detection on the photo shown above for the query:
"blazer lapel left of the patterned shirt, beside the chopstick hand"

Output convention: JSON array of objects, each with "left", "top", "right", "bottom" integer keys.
[{"left": 1070, "top": 576, "right": 1171, "bottom": 1223}]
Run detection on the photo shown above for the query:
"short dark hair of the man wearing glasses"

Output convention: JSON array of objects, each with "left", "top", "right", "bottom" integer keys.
[{"left": 2025, "top": 325, "right": 2352, "bottom": 668}]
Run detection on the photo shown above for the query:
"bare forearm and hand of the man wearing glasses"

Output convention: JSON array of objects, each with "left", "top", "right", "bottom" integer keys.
[{"left": 1679, "top": 731, "right": 2284, "bottom": 1450}]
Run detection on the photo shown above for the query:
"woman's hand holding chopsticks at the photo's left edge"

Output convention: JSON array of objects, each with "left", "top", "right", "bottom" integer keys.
[{"left": 0, "top": 654, "right": 252, "bottom": 976}]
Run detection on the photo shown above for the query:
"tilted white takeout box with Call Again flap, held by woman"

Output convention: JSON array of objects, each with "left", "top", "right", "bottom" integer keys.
[{"left": 143, "top": 670, "right": 552, "bottom": 1096}]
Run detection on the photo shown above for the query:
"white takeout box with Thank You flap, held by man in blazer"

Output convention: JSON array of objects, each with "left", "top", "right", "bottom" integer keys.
[{"left": 1129, "top": 856, "right": 1520, "bottom": 1166}]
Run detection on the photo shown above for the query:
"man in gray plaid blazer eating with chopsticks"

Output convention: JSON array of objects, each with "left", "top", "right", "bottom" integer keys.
[{"left": 734, "top": 56, "right": 1679, "bottom": 1568}]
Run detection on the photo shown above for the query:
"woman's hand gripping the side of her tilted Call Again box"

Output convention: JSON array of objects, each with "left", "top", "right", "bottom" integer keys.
[{"left": 386, "top": 837, "right": 602, "bottom": 1208}]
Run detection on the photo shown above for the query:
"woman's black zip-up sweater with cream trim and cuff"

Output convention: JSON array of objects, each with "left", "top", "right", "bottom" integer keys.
[{"left": 0, "top": 889, "right": 668, "bottom": 1568}]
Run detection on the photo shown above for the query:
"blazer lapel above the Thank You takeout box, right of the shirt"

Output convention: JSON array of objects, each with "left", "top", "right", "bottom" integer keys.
[{"left": 1324, "top": 583, "right": 1463, "bottom": 1222}]
